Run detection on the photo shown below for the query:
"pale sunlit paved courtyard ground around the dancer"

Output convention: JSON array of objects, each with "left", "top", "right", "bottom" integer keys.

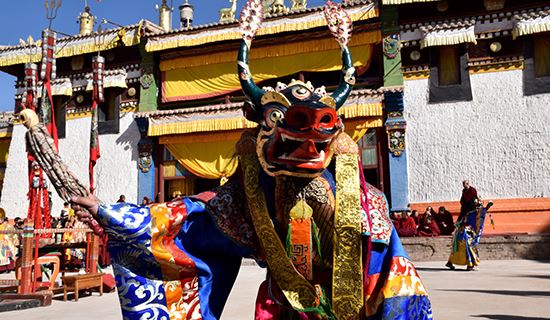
[{"left": 0, "top": 260, "right": 550, "bottom": 320}]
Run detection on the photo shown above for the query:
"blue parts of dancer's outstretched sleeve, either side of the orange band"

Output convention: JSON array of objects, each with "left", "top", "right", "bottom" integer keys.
[{"left": 98, "top": 199, "right": 250, "bottom": 320}]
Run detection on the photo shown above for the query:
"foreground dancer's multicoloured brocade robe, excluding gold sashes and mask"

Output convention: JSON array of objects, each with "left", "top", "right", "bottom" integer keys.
[{"left": 99, "top": 170, "right": 431, "bottom": 319}]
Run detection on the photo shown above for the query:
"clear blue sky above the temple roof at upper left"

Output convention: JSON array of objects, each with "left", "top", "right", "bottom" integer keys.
[{"left": 0, "top": 0, "right": 324, "bottom": 111}]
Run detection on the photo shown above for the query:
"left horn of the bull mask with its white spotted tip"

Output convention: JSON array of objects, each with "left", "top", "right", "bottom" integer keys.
[{"left": 237, "top": 0, "right": 265, "bottom": 107}]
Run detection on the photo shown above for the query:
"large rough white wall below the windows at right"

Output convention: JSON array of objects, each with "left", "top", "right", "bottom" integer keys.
[{"left": 405, "top": 70, "right": 550, "bottom": 203}]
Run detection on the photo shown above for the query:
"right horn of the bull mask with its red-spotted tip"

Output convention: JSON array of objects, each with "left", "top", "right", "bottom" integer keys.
[{"left": 323, "top": 0, "right": 355, "bottom": 110}]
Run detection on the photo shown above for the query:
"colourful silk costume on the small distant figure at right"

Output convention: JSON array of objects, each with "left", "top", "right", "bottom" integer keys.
[{"left": 449, "top": 203, "right": 492, "bottom": 269}]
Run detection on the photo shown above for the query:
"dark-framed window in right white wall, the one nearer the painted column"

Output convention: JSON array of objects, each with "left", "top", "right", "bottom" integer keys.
[{"left": 430, "top": 44, "right": 472, "bottom": 103}]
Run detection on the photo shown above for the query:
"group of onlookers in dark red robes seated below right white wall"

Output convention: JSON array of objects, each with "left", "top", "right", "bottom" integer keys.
[{"left": 390, "top": 207, "right": 455, "bottom": 237}]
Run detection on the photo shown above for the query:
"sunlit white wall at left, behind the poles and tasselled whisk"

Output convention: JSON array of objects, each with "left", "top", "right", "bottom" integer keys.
[{"left": 0, "top": 113, "right": 140, "bottom": 218}]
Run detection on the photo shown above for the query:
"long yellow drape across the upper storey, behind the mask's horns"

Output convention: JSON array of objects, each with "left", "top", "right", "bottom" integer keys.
[{"left": 161, "top": 32, "right": 380, "bottom": 102}]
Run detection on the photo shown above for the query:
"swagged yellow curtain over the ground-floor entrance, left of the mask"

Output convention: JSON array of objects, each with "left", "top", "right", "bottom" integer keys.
[{"left": 166, "top": 141, "right": 238, "bottom": 179}]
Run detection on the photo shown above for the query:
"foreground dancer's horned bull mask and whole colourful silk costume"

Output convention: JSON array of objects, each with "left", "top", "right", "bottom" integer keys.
[{"left": 92, "top": 0, "right": 432, "bottom": 320}]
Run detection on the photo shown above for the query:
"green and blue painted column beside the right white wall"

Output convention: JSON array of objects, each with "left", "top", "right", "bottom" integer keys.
[{"left": 380, "top": 6, "right": 409, "bottom": 212}]
